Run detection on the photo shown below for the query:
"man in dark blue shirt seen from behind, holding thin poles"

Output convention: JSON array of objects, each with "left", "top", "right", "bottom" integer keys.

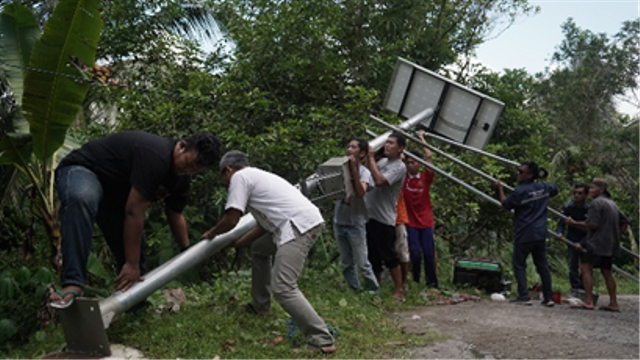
[{"left": 496, "top": 161, "right": 558, "bottom": 306}]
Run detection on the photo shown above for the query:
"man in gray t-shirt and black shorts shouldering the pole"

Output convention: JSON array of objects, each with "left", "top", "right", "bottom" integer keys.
[{"left": 365, "top": 132, "right": 407, "bottom": 301}]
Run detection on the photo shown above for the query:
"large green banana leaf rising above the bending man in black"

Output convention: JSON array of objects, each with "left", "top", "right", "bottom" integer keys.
[{"left": 23, "top": 0, "right": 102, "bottom": 160}]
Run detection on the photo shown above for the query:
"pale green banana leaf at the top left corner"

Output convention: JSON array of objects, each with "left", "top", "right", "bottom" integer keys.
[{"left": 0, "top": 4, "right": 40, "bottom": 109}]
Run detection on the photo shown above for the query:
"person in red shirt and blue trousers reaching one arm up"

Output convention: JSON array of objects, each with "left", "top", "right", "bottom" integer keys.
[{"left": 402, "top": 131, "right": 438, "bottom": 289}]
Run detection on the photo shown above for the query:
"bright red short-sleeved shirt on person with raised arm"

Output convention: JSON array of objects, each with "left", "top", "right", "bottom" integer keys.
[{"left": 402, "top": 170, "right": 435, "bottom": 229}]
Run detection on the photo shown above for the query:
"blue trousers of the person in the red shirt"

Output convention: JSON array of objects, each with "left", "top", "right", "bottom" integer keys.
[{"left": 407, "top": 226, "right": 438, "bottom": 288}]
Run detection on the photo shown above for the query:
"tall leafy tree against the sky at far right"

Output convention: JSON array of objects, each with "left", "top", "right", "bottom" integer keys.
[{"left": 535, "top": 19, "right": 640, "bottom": 211}]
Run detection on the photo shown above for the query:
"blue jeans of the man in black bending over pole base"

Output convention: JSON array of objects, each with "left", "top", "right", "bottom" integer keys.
[{"left": 56, "top": 165, "right": 146, "bottom": 288}]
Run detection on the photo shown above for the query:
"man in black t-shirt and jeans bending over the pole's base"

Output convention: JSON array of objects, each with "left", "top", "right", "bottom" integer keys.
[{"left": 50, "top": 131, "right": 221, "bottom": 308}]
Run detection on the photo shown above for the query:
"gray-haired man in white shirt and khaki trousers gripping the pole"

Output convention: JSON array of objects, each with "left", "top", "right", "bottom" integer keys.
[{"left": 202, "top": 150, "right": 336, "bottom": 353}]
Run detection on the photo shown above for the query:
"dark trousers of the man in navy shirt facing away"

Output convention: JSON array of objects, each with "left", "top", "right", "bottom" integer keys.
[{"left": 513, "top": 240, "right": 553, "bottom": 300}]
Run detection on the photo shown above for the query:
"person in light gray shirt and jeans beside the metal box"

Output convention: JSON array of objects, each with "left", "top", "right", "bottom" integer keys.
[{"left": 333, "top": 138, "right": 380, "bottom": 294}]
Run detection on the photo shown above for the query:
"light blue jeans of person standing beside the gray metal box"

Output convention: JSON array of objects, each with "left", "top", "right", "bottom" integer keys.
[{"left": 333, "top": 224, "right": 380, "bottom": 293}]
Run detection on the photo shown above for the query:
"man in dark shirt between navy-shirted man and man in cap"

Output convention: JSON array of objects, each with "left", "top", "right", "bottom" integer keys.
[{"left": 556, "top": 184, "right": 589, "bottom": 296}]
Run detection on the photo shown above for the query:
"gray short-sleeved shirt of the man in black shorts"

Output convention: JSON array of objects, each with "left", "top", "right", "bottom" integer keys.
[{"left": 364, "top": 158, "right": 407, "bottom": 226}]
